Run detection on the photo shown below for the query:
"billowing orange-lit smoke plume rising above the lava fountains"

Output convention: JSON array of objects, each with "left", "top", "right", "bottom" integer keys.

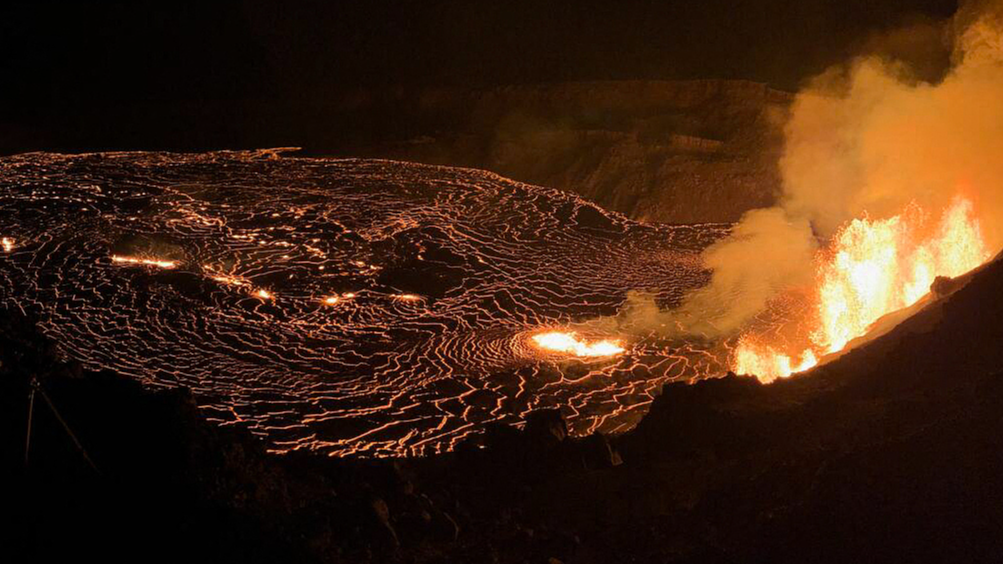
[{"left": 645, "top": 0, "right": 1003, "bottom": 335}]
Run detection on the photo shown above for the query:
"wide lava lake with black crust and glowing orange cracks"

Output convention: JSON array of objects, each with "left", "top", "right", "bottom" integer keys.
[{"left": 0, "top": 152, "right": 729, "bottom": 456}]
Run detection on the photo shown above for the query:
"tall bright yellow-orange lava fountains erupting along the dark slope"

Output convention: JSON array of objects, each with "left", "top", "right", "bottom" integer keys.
[{"left": 732, "top": 197, "right": 990, "bottom": 382}]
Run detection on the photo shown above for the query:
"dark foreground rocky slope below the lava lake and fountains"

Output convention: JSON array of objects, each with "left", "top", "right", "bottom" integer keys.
[{"left": 7, "top": 252, "right": 1003, "bottom": 562}]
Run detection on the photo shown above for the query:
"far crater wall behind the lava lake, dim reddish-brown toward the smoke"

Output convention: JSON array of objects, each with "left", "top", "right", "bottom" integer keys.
[{"left": 0, "top": 80, "right": 792, "bottom": 223}]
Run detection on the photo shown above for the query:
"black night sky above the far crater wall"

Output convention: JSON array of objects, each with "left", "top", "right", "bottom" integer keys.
[{"left": 0, "top": 0, "right": 957, "bottom": 151}]
